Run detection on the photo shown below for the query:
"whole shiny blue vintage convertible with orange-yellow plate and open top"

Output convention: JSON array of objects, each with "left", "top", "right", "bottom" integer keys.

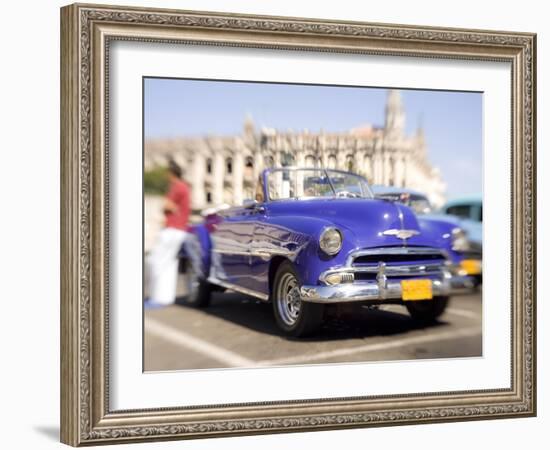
[{"left": 183, "top": 167, "right": 472, "bottom": 336}]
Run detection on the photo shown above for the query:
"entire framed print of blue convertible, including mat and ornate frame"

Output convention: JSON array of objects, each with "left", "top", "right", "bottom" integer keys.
[{"left": 61, "top": 5, "right": 536, "bottom": 446}]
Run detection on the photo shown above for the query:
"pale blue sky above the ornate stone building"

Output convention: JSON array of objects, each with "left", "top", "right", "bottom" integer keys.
[{"left": 144, "top": 78, "right": 482, "bottom": 199}]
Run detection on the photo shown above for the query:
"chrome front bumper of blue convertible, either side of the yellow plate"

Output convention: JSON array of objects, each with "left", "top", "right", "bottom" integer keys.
[{"left": 300, "top": 276, "right": 474, "bottom": 303}]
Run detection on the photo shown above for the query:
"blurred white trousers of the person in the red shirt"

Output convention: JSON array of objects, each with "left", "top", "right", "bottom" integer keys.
[{"left": 147, "top": 228, "right": 188, "bottom": 305}]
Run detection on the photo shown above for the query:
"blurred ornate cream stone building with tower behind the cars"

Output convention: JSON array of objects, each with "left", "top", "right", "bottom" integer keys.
[{"left": 144, "top": 90, "right": 446, "bottom": 209}]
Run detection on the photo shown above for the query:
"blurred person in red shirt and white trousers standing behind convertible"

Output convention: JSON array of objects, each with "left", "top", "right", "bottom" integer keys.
[{"left": 146, "top": 161, "right": 191, "bottom": 307}]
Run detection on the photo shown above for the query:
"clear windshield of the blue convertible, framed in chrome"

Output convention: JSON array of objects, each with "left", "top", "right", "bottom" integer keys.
[{"left": 267, "top": 168, "right": 373, "bottom": 200}]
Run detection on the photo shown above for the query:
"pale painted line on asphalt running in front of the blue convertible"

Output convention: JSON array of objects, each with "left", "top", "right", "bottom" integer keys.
[{"left": 257, "top": 327, "right": 481, "bottom": 366}]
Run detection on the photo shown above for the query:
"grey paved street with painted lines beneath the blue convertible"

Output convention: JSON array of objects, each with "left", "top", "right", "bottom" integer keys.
[{"left": 144, "top": 278, "right": 482, "bottom": 371}]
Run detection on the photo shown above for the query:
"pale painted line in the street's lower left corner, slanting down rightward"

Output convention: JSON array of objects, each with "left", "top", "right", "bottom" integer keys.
[{"left": 145, "top": 317, "right": 257, "bottom": 367}]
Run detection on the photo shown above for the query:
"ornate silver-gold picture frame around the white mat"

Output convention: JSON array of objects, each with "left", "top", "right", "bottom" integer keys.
[{"left": 61, "top": 4, "right": 536, "bottom": 446}]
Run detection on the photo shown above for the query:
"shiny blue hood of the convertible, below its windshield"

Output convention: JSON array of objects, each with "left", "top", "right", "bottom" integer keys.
[{"left": 269, "top": 199, "right": 440, "bottom": 248}]
